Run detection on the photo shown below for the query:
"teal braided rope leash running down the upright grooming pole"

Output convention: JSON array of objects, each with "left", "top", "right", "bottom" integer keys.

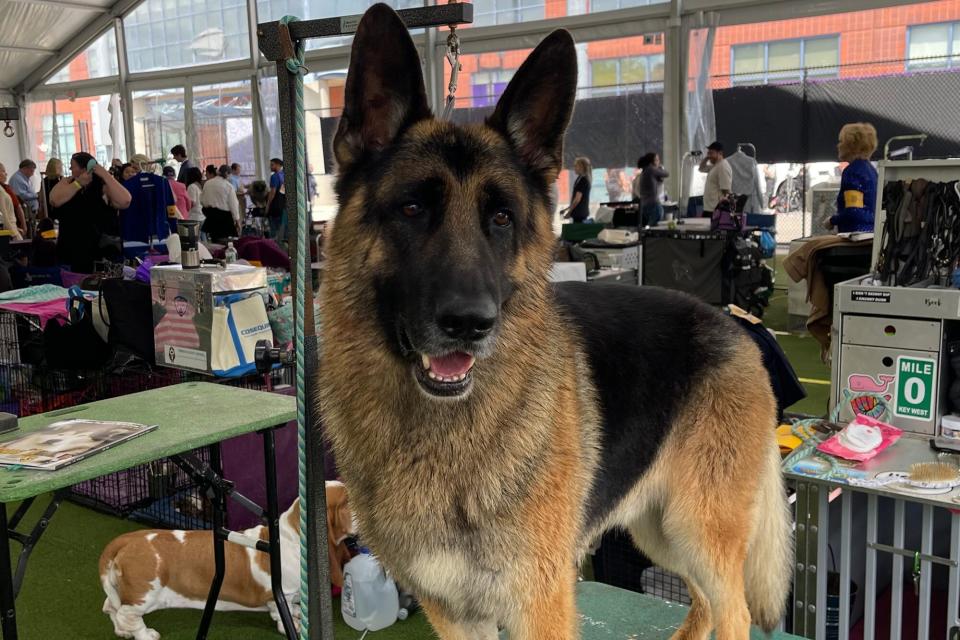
[{"left": 280, "top": 16, "right": 310, "bottom": 640}]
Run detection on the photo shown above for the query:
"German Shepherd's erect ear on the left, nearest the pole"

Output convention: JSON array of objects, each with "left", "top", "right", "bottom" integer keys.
[{"left": 333, "top": 4, "right": 430, "bottom": 172}]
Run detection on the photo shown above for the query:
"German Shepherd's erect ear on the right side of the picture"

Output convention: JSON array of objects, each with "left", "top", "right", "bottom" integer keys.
[{"left": 487, "top": 29, "right": 577, "bottom": 181}]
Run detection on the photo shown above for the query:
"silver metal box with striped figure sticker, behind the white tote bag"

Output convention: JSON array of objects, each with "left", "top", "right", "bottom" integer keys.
[{"left": 150, "top": 264, "right": 268, "bottom": 374}]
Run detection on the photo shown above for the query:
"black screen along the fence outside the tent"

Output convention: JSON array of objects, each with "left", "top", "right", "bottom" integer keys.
[{"left": 321, "top": 71, "right": 960, "bottom": 168}]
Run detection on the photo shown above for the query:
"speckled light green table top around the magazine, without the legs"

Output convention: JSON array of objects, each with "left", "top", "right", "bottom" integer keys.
[{"left": 0, "top": 382, "right": 297, "bottom": 503}]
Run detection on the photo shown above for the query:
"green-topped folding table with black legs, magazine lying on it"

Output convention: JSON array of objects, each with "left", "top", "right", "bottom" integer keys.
[{"left": 0, "top": 382, "right": 296, "bottom": 640}]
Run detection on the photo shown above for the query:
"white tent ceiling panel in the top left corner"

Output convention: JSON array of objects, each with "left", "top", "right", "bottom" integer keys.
[{"left": 0, "top": 0, "right": 114, "bottom": 88}]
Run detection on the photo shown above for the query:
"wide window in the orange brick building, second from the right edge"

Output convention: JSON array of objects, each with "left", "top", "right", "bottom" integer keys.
[{"left": 731, "top": 36, "right": 840, "bottom": 84}]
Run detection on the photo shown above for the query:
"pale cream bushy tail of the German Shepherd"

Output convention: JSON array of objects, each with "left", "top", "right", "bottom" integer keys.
[{"left": 744, "top": 437, "right": 793, "bottom": 633}]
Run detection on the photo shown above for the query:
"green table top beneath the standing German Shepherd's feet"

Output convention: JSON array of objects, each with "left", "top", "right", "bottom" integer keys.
[{"left": 577, "top": 582, "right": 799, "bottom": 640}]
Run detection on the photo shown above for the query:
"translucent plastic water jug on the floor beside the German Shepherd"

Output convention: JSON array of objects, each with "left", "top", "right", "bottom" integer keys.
[{"left": 340, "top": 549, "right": 400, "bottom": 631}]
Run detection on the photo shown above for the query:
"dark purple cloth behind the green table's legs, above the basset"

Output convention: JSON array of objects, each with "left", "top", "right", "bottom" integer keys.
[{"left": 221, "top": 387, "right": 337, "bottom": 531}]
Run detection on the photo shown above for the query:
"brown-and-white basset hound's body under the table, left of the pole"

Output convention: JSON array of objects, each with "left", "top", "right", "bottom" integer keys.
[{"left": 100, "top": 500, "right": 302, "bottom": 640}]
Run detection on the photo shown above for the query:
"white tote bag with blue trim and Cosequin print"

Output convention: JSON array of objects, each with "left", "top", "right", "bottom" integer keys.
[{"left": 210, "top": 293, "right": 273, "bottom": 378}]
